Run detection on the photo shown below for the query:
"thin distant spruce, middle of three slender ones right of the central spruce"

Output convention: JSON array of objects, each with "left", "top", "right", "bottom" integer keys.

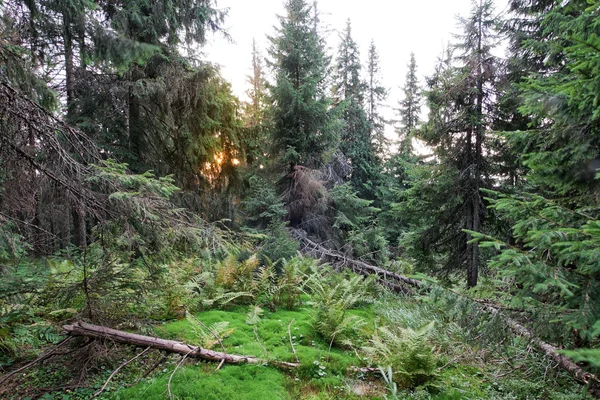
[{"left": 367, "top": 41, "right": 389, "bottom": 155}]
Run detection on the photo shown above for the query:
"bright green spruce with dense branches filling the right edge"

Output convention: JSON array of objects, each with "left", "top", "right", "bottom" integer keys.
[{"left": 477, "top": 1, "right": 600, "bottom": 350}]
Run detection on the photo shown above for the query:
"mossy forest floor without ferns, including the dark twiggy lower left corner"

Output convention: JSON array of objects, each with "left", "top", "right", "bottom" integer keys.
[{"left": 0, "top": 294, "right": 589, "bottom": 400}]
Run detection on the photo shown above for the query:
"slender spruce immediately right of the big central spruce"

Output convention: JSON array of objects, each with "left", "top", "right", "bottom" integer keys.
[{"left": 333, "top": 20, "right": 378, "bottom": 198}]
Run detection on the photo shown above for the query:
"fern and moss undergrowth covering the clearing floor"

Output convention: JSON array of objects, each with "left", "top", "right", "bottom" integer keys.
[{"left": 0, "top": 253, "right": 588, "bottom": 400}]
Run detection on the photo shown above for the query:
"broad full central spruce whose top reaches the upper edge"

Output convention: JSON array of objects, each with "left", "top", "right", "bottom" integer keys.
[{"left": 269, "top": 0, "right": 337, "bottom": 169}]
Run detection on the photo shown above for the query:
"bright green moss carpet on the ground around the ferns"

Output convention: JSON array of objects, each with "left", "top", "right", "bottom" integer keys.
[{"left": 103, "top": 299, "right": 588, "bottom": 400}]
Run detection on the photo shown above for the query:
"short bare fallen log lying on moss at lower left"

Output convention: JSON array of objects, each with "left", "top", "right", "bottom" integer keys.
[{"left": 63, "top": 321, "right": 300, "bottom": 369}]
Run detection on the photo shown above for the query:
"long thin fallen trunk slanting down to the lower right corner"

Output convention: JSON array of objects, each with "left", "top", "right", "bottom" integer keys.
[{"left": 292, "top": 230, "right": 600, "bottom": 398}]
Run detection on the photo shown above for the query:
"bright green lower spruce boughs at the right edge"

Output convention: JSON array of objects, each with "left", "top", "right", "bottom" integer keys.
[{"left": 474, "top": 192, "right": 600, "bottom": 339}]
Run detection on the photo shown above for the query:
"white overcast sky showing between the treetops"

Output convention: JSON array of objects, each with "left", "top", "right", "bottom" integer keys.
[{"left": 204, "top": 0, "right": 507, "bottom": 142}]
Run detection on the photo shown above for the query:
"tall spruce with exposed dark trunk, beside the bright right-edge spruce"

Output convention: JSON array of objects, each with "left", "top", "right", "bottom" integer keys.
[{"left": 407, "top": 1, "right": 496, "bottom": 287}]
